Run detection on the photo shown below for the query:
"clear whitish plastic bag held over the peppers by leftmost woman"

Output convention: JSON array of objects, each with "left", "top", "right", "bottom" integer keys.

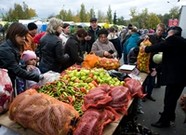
[{"left": 39, "top": 71, "right": 60, "bottom": 86}]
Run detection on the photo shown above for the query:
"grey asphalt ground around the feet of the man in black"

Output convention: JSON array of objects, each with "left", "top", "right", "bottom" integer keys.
[{"left": 137, "top": 86, "right": 186, "bottom": 135}]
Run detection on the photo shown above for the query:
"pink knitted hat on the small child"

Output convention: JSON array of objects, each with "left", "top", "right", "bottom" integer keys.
[{"left": 22, "top": 50, "right": 37, "bottom": 62}]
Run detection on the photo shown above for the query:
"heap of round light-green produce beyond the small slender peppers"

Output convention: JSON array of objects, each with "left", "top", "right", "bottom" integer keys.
[{"left": 61, "top": 68, "right": 123, "bottom": 91}]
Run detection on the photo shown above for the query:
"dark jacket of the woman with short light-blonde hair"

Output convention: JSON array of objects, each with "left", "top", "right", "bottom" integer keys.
[{"left": 39, "top": 33, "right": 69, "bottom": 73}]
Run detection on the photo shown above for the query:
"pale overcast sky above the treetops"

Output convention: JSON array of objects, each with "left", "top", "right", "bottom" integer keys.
[{"left": 0, "top": 0, "right": 186, "bottom": 19}]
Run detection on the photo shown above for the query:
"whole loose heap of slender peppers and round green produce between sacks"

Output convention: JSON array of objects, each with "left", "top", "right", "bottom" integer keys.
[{"left": 38, "top": 68, "right": 124, "bottom": 115}]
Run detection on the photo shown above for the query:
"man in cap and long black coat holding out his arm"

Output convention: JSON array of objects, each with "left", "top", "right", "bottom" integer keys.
[{"left": 142, "top": 26, "right": 186, "bottom": 128}]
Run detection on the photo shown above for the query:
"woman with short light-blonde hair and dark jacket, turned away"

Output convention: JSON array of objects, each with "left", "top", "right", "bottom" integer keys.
[{"left": 39, "top": 18, "right": 69, "bottom": 73}]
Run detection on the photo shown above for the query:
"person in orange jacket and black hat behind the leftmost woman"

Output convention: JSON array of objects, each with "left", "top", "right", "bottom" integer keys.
[{"left": 24, "top": 22, "right": 38, "bottom": 51}]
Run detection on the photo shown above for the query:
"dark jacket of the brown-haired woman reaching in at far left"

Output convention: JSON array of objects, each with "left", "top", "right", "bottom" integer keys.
[{"left": 0, "top": 40, "right": 39, "bottom": 85}]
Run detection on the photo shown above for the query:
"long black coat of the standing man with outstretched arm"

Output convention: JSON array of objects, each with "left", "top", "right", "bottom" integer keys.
[{"left": 145, "top": 35, "right": 186, "bottom": 85}]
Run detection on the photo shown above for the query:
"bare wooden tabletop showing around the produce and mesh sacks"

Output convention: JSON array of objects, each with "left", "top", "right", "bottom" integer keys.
[{"left": 0, "top": 73, "right": 147, "bottom": 135}]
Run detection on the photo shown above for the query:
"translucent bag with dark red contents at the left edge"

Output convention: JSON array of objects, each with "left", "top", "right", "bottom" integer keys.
[{"left": 0, "top": 68, "right": 13, "bottom": 114}]
